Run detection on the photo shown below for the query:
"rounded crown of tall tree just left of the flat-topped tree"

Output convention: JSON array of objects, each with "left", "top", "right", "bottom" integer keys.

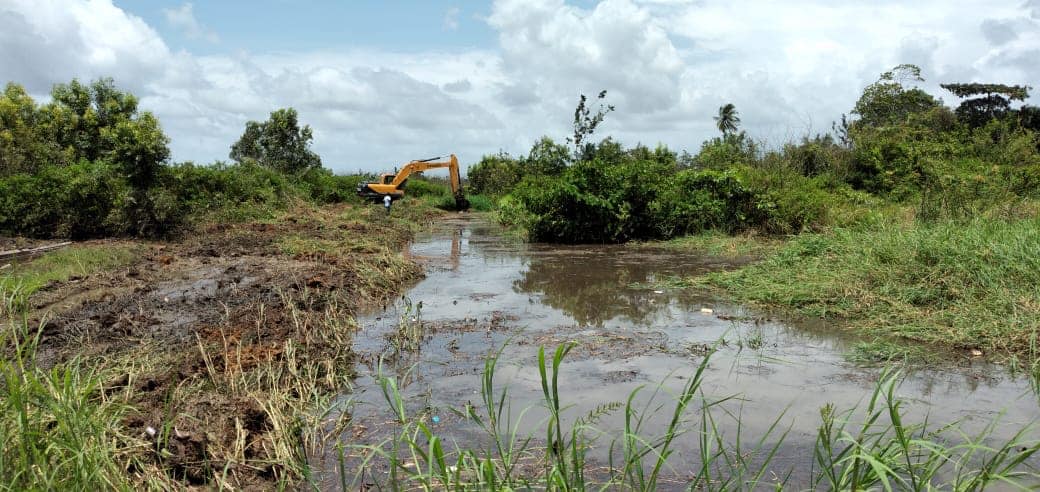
[{"left": 852, "top": 64, "right": 939, "bottom": 127}]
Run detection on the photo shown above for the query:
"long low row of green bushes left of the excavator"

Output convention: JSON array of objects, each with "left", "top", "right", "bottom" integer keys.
[{"left": 0, "top": 157, "right": 374, "bottom": 238}]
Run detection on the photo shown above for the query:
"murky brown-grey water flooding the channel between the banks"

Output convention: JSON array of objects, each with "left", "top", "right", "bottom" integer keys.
[{"left": 314, "top": 218, "right": 1040, "bottom": 489}]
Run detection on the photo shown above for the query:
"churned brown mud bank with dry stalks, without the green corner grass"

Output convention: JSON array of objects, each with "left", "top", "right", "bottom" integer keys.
[{"left": 3, "top": 201, "right": 438, "bottom": 489}]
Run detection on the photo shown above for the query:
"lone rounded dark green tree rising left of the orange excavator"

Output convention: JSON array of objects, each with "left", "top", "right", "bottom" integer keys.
[{"left": 230, "top": 107, "right": 321, "bottom": 174}]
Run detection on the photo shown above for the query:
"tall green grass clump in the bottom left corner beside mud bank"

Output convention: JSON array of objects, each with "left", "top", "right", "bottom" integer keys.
[{"left": 0, "top": 321, "right": 141, "bottom": 490}]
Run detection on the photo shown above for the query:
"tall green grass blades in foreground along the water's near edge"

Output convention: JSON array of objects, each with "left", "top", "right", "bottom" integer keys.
[{"left": 340, "top": 345, "right": 1040, "bottom": 491}]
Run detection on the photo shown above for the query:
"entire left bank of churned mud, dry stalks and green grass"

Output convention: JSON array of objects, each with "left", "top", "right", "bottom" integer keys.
[{"left": 0, "top": 199, "right": 437, "bottom": 488}]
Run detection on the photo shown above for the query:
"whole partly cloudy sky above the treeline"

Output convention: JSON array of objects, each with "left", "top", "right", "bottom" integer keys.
[{"left": 0, "top": 0, "right": 1040, "bottom": 173}]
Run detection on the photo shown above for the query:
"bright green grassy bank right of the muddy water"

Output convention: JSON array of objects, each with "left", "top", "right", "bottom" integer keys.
[{"left": 700, "top": 218, "right": 1040, "bottom": 354}]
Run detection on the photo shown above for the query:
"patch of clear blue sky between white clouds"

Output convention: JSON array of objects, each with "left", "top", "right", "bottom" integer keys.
[{"left": 125, "top": 0, "right": 496, "bottom": 54}]
